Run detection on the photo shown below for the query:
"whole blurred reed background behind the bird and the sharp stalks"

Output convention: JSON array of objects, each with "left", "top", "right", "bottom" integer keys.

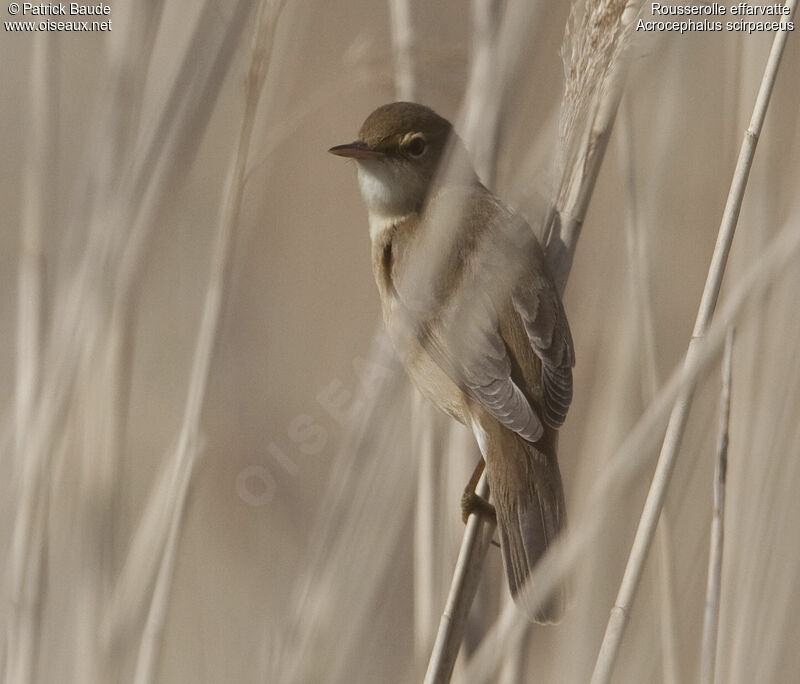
[{"left": 0, "top": 0, "right": 800, "bottom": 684}]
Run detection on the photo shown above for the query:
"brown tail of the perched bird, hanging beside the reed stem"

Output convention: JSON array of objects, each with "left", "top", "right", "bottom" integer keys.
[{"left": 486, "top": 428, "right": 566, "bottom": 623}]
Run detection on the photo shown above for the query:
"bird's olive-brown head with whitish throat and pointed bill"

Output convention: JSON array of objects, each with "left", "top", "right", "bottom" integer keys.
[{"left": 329, "top": 102, "right": 471, "bottom": 219}]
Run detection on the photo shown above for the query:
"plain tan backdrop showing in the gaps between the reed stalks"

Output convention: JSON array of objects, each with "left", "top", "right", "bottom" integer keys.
[{"left": 0, "top": 1, "right": 800, "bottom": 682}]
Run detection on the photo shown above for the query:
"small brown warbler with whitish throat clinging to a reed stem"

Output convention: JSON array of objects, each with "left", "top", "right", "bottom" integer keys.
[{"left": 330, "top": 102, "right": 575, "bottom": 622}]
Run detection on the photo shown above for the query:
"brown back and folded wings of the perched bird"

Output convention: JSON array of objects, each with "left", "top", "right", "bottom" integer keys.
[{"left": 394, "top": 187, "right": 574, "bottom": 442}]
